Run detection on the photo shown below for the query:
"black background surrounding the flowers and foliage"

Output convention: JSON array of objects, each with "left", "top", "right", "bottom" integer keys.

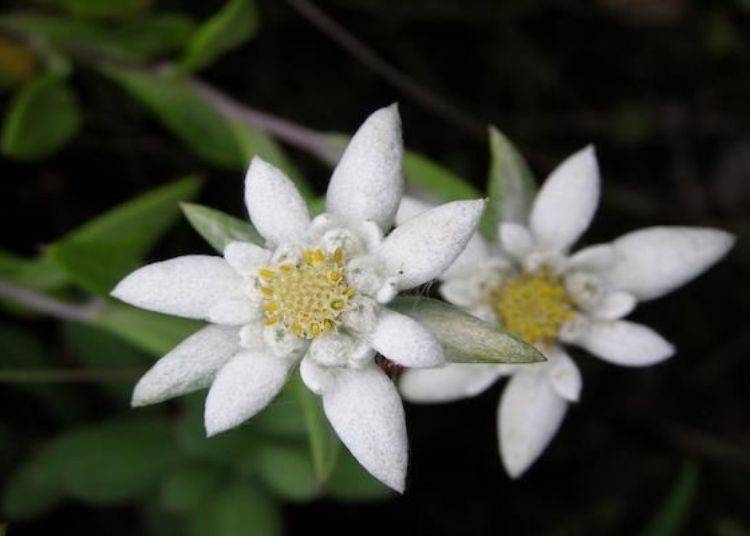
[{"left": 0, "top": 0, "right": 750, "bottom": 536}]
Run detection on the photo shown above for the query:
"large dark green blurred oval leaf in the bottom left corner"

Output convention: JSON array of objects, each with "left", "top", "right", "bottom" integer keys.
[{"left": 5, "top": 418, "right": 176, "bottom": 509}]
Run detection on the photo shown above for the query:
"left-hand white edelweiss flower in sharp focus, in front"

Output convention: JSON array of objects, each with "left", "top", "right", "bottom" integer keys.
[{"left": 112, "top": 105, "right": 484, "bottom": 491}]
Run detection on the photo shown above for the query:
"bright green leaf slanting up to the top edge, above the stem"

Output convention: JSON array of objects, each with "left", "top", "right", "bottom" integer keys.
[{"left": 181, "top": 0, "right": 260, "bottom": 71}]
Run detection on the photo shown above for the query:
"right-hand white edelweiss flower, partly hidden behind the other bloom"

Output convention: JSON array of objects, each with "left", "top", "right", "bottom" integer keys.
[{"left": 396, "top": 147, "right": 734, "bottom": 478}]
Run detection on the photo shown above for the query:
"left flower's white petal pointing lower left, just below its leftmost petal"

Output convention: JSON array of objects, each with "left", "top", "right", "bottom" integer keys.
[{"left": 131, "top": 326, "right": 240, "bottom": 406}]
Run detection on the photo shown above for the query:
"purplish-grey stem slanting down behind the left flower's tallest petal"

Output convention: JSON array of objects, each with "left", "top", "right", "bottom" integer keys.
[{"left": 190, "top": 78, "right": 341, "bottom": 164}]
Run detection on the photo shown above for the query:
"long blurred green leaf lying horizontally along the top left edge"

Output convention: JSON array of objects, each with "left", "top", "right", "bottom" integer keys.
[{"left": 0, "top": 13, "right": 195, "bottom": 62}]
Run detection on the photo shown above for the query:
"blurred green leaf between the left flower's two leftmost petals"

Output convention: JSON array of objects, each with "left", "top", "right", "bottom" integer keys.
[{"left": 88, "top": 304, "right": 203, "bottom": 357}]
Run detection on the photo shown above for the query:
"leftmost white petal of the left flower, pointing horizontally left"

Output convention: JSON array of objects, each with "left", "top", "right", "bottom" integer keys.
[{"left": 112, "top": 255, "right": 242, "bottom": 319}]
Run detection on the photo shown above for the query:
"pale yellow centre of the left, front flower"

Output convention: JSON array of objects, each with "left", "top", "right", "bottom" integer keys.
[{"left": 258, "top": 249, "right": 354, "bottom": 339}]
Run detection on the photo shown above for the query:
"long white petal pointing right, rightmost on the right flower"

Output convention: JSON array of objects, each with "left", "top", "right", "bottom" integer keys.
[{"left": 605, "top": 227, "right": 734, "bottom": 301}]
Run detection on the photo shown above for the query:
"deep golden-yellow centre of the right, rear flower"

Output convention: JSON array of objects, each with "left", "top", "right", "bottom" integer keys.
[{"left": 491, "top": 270, "right": 575, "bottom": 345}]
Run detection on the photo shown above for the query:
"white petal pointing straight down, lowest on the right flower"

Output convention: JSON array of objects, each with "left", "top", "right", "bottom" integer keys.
[{"left": 498, "top": 365, "right": 568, "bottom": 478}]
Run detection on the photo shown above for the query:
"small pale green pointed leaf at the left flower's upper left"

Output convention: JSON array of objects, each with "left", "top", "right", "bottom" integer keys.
[{"left": 180, "top": 203, "right": 265, "bottom": 254}]
